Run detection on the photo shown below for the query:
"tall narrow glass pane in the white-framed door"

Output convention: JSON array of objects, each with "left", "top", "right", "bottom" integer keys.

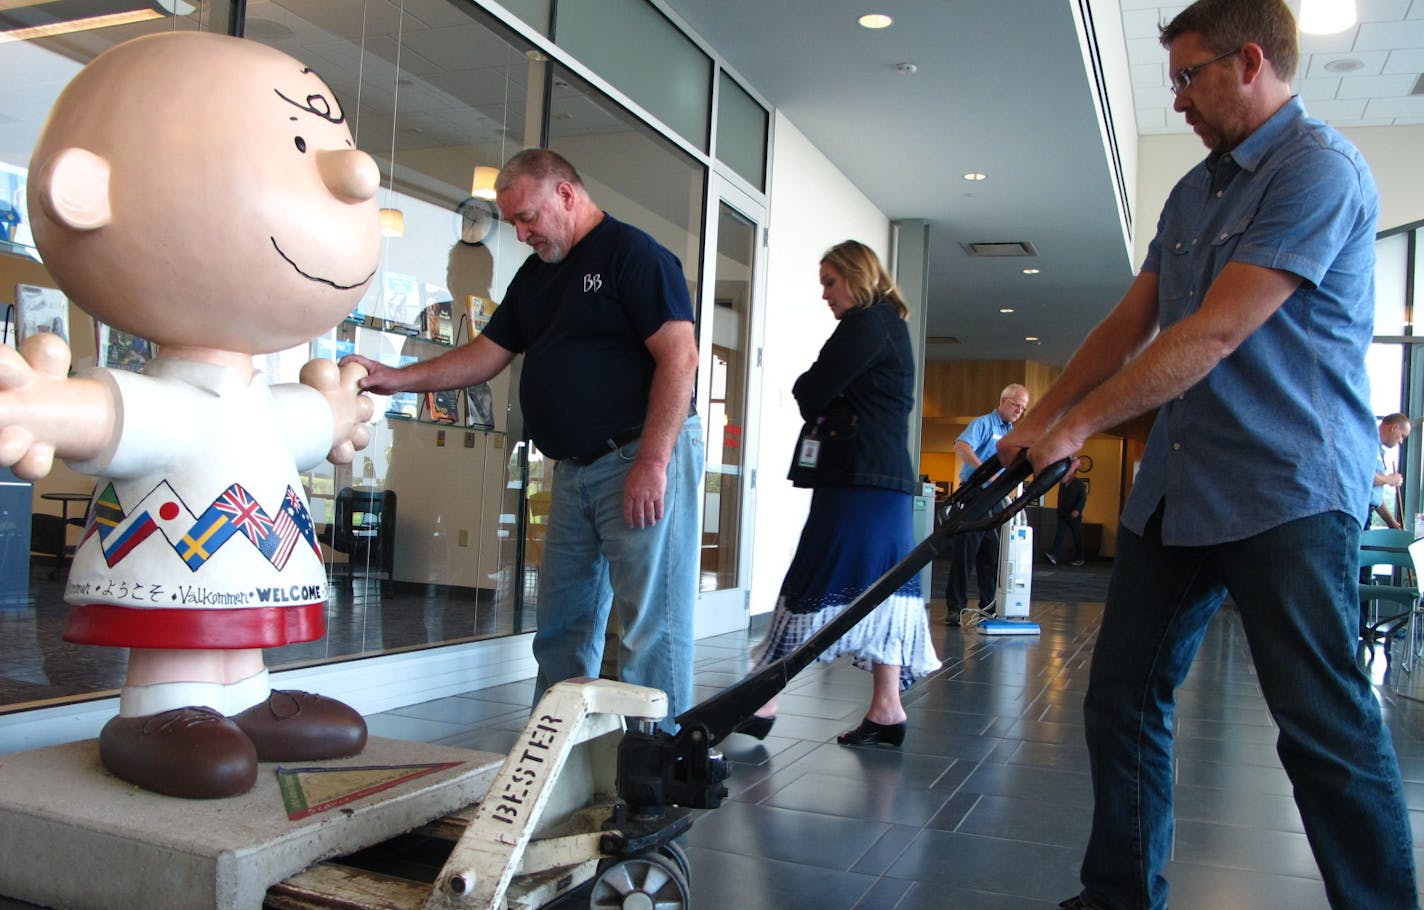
[{"left": 701, "top": 202, "right": 756, "bottom": 591}]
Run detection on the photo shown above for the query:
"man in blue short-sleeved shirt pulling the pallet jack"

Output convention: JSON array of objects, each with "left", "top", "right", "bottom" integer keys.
[{"left": 998, "top": 0, "right": 1417, "bottom": 910}]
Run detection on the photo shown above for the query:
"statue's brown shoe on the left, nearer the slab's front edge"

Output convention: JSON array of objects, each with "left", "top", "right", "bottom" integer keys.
[{"left": 98, "top": 708, "right": 258, "bottom": 799}]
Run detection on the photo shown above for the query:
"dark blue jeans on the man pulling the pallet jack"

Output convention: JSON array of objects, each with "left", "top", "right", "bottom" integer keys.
[{"left": 1082, "top": 504, "right": 1417, "bottom": 910}]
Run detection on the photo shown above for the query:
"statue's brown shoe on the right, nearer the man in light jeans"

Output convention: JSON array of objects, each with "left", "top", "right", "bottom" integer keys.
[{"left": 232, "top": 689, "right": 366, "bottom": 762}]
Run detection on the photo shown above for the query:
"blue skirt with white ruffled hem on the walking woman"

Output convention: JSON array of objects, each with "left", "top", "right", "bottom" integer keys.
[{"left": 752, "top": 487, "right": 940, "bottom": 689}]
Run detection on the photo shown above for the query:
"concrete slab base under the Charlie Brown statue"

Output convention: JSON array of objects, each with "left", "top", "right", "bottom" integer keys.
[{"left": 0, "top": 738, "right": 504, "bottom": 910}]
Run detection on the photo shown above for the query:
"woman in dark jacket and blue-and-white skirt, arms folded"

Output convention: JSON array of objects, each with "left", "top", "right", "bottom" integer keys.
[{"left": 738, "top": 241, "right": 940, "bottom": 746}]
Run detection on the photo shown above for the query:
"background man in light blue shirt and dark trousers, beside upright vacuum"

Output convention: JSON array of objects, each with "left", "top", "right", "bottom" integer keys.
[{"left": 944, "top": 382, "right": 1028, "bottom": 625}]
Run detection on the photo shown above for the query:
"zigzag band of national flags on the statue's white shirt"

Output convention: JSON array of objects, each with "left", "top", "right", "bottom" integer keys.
[{"left": 84, "top": 480, "right": 322, "bottom": 571}]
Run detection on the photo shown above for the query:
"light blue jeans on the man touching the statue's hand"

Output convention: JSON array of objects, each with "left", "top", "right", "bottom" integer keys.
[{"left": 534, "top": 414, "right": 705, "bottom": 731}]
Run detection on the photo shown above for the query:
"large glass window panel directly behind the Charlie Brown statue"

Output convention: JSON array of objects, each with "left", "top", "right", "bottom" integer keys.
[{"left": 0, "top": 0, "right": 547, "bottom": 709}]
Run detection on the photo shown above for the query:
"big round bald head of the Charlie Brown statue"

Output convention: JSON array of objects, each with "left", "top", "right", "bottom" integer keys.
[{"left": 30, "top": 33, "right": 380, "bottom": 353}]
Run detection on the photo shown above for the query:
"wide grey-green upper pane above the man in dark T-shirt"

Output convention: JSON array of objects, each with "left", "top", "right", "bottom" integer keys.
[{"left": 554, "top": 0, "right": 712, "bottom": 150}]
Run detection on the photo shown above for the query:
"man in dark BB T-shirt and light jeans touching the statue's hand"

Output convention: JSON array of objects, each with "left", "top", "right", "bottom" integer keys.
[{"left": 343, "top": 148, "right": 703, "bottom": 731}]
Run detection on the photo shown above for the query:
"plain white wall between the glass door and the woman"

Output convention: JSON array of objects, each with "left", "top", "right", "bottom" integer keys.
[{"left": 743, "top": 114, "right": 890, "bottom": 614}]
